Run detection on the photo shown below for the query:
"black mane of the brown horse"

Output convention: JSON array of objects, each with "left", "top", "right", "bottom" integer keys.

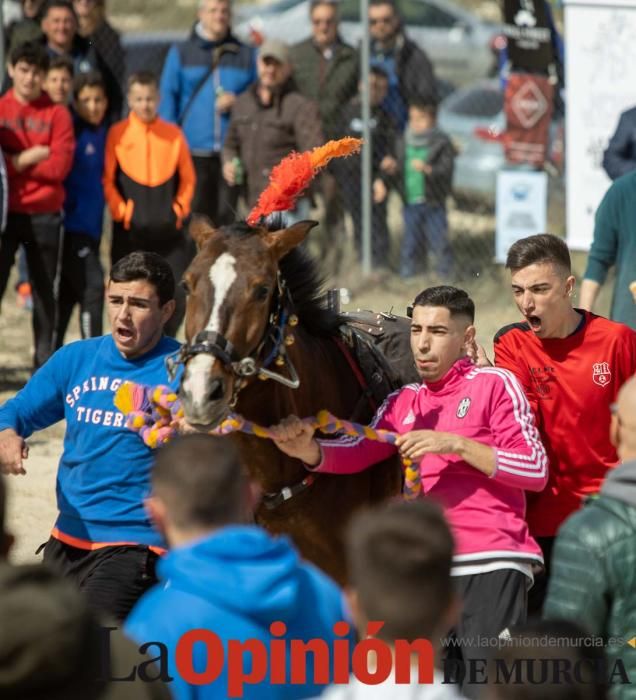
[{"left": 221, "top": 219, "right": 342, "bottom": 337}]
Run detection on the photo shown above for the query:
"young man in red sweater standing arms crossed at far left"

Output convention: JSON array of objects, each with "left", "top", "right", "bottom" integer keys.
[{"left": 0, "top": 43, "right": 75, "bottom": 368}]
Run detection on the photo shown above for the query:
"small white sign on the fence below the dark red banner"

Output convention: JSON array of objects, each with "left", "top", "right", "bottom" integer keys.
[{"left": 495, "top": 170, "right": 548, "bottom": 263}]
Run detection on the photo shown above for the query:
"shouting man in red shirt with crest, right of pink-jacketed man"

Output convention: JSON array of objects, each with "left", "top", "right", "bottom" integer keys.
[{"left": 494, "top": 234, "right": 636, "bottom": 612}]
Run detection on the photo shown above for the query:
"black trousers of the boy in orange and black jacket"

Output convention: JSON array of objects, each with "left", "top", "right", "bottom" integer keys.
[{"left": 111, "top": 222, "right": 196, "bottom": 337}]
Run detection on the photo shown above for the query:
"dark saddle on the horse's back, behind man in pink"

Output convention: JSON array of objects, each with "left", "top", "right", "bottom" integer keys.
[{"left": 340, "top": 310, "right": 420, "bottom": 407}]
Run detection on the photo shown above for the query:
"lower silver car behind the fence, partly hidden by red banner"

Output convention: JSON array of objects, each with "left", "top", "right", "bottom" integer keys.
[{"left": 437, "top": 80, "right": 563, "bottom": 207}]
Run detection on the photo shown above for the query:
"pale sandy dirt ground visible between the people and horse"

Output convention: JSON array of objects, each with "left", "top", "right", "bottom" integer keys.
[{"left": 0, "top": 212, "right": 611, "bottom": 563}]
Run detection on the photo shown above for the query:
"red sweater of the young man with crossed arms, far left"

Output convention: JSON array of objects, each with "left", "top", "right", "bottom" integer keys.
[{"left": 0, "top": 89, "right": 75, "bottom": 214}]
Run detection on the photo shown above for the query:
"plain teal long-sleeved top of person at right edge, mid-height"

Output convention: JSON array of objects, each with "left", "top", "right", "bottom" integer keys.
[{"left": 583, "top": 171, "right": 636, "bottom": 330}]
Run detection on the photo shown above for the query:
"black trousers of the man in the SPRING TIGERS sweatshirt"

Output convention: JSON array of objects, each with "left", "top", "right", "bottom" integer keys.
[{"left": 44, "top": 537, "right": 159, "bottom": 622}]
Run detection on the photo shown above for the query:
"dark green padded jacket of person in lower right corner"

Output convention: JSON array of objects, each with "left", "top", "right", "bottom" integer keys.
[{"left": 543, "top": 461, "right": 636, "bottom": 700}]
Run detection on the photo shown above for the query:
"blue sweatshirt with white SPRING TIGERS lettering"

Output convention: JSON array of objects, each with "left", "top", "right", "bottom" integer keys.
[{"left": 0, "top": 335, "right": 179, "bottom": 548}]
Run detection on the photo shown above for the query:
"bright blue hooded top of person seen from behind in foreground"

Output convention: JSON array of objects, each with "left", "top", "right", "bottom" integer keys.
[{"left": 125, "top": 525, "right": 348, "bottom": 700}]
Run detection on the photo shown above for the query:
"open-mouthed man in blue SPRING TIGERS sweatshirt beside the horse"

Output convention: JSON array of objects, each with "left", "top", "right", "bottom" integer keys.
[{"left": 0, "top": 252, "right": 179, "bottom": 619}]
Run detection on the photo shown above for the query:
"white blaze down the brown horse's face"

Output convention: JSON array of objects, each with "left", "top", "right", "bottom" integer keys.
[{"left": 183, "top": 253, "right": 236, "bottom": 410}]
